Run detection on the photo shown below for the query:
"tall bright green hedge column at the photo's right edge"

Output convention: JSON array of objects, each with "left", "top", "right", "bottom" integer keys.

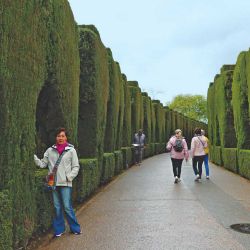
[{"left": 232, "top": 51, "right": 250, "bottom": 149}]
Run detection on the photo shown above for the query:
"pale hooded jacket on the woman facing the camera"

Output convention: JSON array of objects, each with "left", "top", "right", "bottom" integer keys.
[{"left": 35, "top": 144, "right": 80, "bottom": 187}]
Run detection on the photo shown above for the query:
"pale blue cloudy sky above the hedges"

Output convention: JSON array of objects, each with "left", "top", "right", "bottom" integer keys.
[{"left": 69, "top": 0, "right": 250, "bottom": 105}]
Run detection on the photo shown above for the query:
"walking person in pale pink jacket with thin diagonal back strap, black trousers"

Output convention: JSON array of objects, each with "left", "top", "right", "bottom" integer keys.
[{"left": 191, "top": 128, "right": 207, "bottom": 181}]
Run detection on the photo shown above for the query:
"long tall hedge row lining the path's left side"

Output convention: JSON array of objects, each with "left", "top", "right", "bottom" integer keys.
[{"left": 0, "top": 0, "right": 207, "bottom": 249}]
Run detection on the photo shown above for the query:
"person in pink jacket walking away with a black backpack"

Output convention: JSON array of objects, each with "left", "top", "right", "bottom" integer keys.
[{"left": 166, "top": 129, "right": 189, "bottom": 183}]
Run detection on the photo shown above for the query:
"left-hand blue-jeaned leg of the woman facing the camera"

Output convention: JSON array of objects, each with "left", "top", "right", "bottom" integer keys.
[{"left": 52, "top": 187, "right": 65, "bottom": 235}]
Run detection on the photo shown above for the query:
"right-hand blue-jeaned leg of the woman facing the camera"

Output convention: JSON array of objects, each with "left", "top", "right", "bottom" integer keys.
[{"left": 61, "top": 187, "right": 81, "bottom": 233}]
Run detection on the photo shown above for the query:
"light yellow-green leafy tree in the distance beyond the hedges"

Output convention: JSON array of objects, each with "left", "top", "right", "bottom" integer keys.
[{"left": 167, "top": 95, "right": 207, "bottom": 123}]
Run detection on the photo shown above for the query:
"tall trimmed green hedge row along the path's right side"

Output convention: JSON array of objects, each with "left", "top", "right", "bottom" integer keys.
[{"left": 207, "top": 48, "right": 250, "bottom": 178}]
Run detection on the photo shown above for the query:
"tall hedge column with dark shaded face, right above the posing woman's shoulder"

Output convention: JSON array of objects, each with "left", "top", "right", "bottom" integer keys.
[{"left": 78, "top": 25, "right": 109, "bottom": 169}]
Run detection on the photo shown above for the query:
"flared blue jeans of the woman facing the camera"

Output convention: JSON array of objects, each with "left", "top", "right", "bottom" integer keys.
[{"left": 52, "top": 186, "right": 81, "bottom": 234}]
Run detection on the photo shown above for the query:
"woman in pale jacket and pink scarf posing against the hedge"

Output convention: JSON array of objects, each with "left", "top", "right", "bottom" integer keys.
[{"left": 34, "top": 128, "right": 81, "bottom": 237}]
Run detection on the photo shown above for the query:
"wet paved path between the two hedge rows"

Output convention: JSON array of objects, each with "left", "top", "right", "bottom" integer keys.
[{"left": 40, "top": 154, "right": 250, "bottom": 250}]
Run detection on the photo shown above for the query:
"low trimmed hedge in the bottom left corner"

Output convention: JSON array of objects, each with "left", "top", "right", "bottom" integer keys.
[{"left": 0, "top": 190, "right": 13, "bottom": 250}]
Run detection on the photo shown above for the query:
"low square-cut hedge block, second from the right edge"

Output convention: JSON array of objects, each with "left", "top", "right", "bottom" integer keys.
[{"left": 222, "top": 148, "right": 239, "bottom": 174}]
